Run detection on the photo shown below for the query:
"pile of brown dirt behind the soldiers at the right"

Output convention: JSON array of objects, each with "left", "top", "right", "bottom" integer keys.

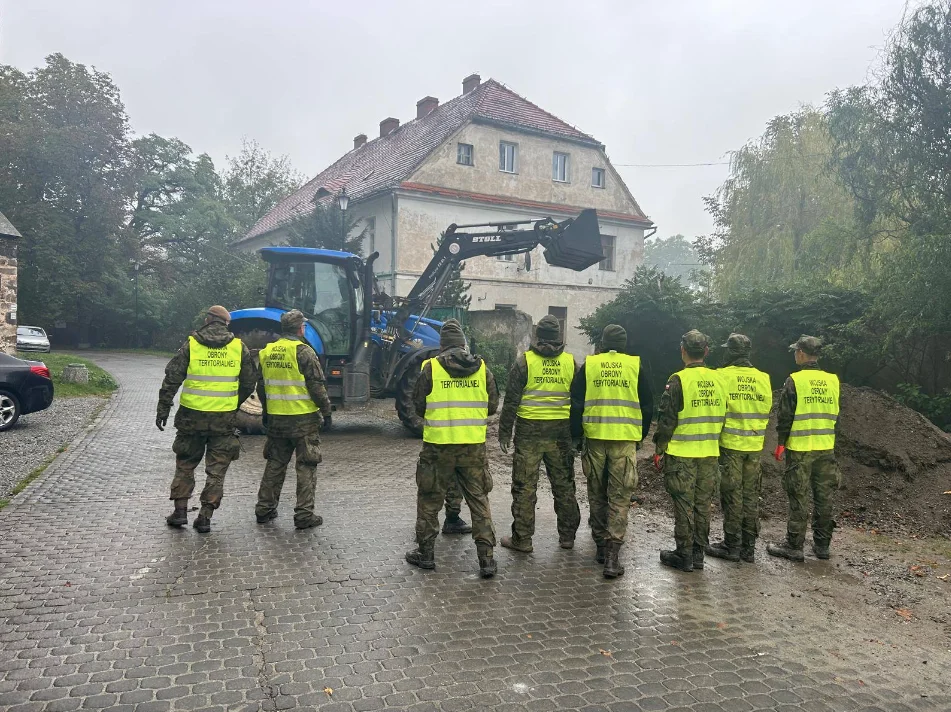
[{"left": 638, "top": 384, "right": 951, "bottom": 536}]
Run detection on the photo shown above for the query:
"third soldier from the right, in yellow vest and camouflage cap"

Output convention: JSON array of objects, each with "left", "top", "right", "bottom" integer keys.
[{"left": 654, "top": 329, "right": 726, "bottom": 571}]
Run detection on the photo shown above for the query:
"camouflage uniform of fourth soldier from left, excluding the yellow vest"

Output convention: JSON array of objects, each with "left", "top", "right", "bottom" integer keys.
[{"left": 499, "top": 326, "right": 581, "bottom": 550}]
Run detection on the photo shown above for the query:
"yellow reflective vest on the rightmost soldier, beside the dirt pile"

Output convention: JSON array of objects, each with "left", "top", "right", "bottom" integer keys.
[{"left": 786, "top": 368, "right": 839, "bottom": 452}]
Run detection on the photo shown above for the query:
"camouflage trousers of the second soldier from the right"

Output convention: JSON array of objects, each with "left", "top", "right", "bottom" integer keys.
[{"left": 720, "top": 447, "right": 763, "bottom": 547}]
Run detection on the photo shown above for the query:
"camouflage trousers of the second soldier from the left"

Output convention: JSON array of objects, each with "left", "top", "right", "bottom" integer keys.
[{"left": 254, "top": 433, "right": 323, "bottom": 526}]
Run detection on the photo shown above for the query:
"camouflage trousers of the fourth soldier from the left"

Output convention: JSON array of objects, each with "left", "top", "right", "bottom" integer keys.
[{"left": 512, "top": 427, "right": 581, "bottom": 543}]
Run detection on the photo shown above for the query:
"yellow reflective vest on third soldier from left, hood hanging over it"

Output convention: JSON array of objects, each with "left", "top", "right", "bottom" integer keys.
[{"left": 423, "top": 358, "right": 489, "bottom": 445}]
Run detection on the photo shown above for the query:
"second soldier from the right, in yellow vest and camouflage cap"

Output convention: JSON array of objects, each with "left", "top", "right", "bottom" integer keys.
[{"left": 706, "top": 334, "right": 773, "bottom": 564}]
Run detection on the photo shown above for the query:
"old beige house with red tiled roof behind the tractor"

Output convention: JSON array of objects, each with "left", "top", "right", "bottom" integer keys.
[{"left": 238, "top": 75, "right": 652, "bottom": 352}]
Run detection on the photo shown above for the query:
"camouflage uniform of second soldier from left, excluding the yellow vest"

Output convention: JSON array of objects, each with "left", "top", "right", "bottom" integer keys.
[{"left": 254, "top": 317, "right": 331, "bottom": 529}]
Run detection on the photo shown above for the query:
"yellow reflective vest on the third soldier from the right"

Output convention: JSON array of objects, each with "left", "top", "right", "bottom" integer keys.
[{"left": 667, "top": 366, "right": 726, "bottom": 457}]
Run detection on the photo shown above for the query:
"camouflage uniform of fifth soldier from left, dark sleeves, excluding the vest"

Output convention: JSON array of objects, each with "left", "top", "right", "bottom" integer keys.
[{"left": 570, "top": 327, "right": 654, "bottom": 556}]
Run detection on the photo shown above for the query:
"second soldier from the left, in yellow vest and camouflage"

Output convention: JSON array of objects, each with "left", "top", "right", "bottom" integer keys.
[{"left": 254, "top": 309, "right": 331, "bottom": 529}]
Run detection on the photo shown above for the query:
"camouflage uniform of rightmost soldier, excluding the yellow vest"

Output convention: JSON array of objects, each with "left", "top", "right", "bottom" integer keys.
[{"left": 776, "top": 361, "right": 842, "bottom": 549}]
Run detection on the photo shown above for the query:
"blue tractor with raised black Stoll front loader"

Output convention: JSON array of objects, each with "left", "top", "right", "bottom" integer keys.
[{"left": 231, "top": 210, "right": 603, "bottom": 435}]
